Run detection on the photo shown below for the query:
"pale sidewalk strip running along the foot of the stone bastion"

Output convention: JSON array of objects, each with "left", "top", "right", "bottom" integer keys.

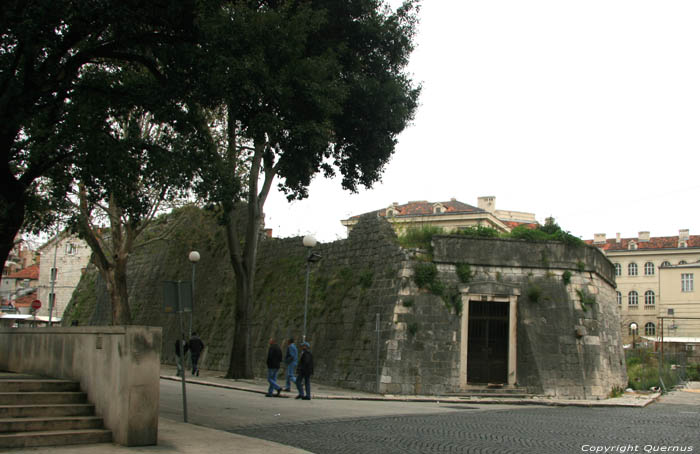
[{"left": 160, "top": 364, "right": 660, "bottom": 407}]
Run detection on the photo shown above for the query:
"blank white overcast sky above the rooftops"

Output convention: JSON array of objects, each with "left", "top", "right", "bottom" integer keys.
[{"left": 264, "top": 0, "right": 700, "bottom": 242}]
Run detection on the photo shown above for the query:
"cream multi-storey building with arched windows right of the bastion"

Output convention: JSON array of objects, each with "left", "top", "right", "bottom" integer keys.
[{"left": 588, "top": 229, "right": 700, "bottom": 344}]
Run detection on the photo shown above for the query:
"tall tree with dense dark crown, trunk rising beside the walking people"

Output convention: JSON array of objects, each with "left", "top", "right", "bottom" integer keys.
[{"left": 193, "top": 0, "right": 420, "bottom": 378}]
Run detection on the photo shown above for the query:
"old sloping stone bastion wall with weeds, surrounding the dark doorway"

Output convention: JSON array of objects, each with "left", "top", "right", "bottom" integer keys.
[{"left": 63, "top": 209, "right": 626, "bottom": 398}]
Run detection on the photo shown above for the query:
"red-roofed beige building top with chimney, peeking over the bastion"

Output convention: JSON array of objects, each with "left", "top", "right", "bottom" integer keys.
[{"left": 341, "top": 196, "right": 537, "bottom": 234}]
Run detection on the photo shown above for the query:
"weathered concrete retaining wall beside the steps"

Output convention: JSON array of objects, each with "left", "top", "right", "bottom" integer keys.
[{"left": 0, "top": 326, "right": 162, "bottom": 446}]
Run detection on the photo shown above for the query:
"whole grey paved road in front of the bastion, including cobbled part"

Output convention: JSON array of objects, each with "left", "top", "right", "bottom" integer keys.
[{"left": 161, "top": 381, "right": 700, "bottom": 454}]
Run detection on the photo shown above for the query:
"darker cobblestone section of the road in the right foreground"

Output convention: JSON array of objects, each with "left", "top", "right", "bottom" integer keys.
[{"left": 231, "top": 403, "right": 700, "bottom": 454}]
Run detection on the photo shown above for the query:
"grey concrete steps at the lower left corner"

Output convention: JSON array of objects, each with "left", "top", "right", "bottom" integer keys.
[{"left": 0, "top": 373, "right": 112, "bottom": 449}]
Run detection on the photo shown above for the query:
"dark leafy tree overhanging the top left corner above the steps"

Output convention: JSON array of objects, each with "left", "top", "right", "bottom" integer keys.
[{"left": 0, "top": 0, "right": 208, "bottom": 271}]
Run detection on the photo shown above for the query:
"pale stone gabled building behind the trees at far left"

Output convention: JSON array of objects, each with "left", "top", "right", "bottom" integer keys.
[{"left": 37, "top": 233, "right": 92, "bottom": 318}]
